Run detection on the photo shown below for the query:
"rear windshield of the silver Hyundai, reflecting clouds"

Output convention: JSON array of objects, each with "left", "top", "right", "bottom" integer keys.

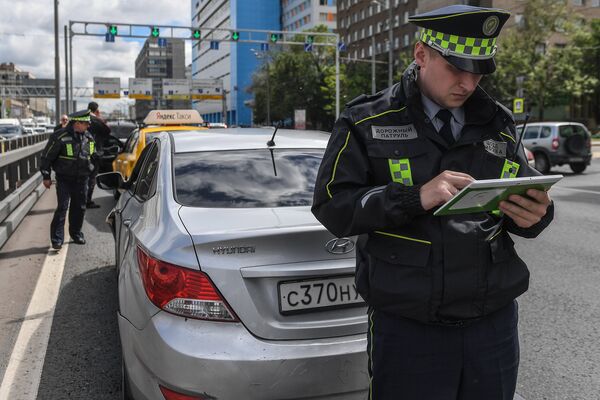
[{"left": 173, "top": 149, "right": 323, "bottom": 208}]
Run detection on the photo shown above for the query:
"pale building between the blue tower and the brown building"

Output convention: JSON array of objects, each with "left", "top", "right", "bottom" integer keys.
[{"left": 281, "top": 0, "right": 340, "bottom": 31}]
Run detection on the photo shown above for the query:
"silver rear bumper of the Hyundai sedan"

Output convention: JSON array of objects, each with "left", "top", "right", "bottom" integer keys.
[{"left": 119, "top": 312, "right": 368, "bottom": 400}]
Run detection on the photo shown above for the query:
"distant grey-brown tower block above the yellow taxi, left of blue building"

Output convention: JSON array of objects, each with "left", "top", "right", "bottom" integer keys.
[{"left": 135, "top": 38, "right": 190, "bottom": 119}]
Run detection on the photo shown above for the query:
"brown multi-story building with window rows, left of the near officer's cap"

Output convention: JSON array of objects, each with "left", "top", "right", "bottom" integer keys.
[{"left": 337, "top": 0, "right": 418, "bottom": 69}]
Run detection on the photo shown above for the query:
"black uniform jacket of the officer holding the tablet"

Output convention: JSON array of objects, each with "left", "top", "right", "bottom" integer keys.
[{"left": 312, "top": 64, "right": 553, "bottom": 324}]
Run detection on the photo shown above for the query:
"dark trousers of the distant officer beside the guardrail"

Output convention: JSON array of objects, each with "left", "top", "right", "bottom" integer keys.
[{"left": 50, "top": 177, "right": 88, "bottom": 244}]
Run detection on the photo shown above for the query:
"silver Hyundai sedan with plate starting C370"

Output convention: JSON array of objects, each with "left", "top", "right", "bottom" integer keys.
[{"left": 97, "top": 128, "right": 369, "bottom": 400}]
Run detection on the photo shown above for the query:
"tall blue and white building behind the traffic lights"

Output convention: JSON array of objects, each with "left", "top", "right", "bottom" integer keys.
[{"left": 191, "top": 0, "right": 281, "bottom": 125}]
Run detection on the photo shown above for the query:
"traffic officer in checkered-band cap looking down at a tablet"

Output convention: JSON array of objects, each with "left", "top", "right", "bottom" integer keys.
[{"left": 312, "top": 5, "right": 553, "bottom": 400}]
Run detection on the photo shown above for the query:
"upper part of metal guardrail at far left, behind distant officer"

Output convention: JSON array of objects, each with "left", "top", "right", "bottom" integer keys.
[{"left": 0, "top": 141, "right": 47, "bottom": 201}]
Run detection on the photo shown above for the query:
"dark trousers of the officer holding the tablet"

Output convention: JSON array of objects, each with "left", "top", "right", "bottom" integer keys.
[{"left": 367, "top": 301, "right": 519, "bottom": 400}]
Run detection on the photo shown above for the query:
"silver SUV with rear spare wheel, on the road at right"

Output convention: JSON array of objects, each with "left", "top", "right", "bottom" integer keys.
[{"left": 517, "top": 122, "right": 592, "bottom": 174}]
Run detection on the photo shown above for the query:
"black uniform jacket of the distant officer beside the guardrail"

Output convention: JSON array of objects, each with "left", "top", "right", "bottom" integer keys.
[{"left": 40, "top": 124, "right": 96, "bottom": 179}]
